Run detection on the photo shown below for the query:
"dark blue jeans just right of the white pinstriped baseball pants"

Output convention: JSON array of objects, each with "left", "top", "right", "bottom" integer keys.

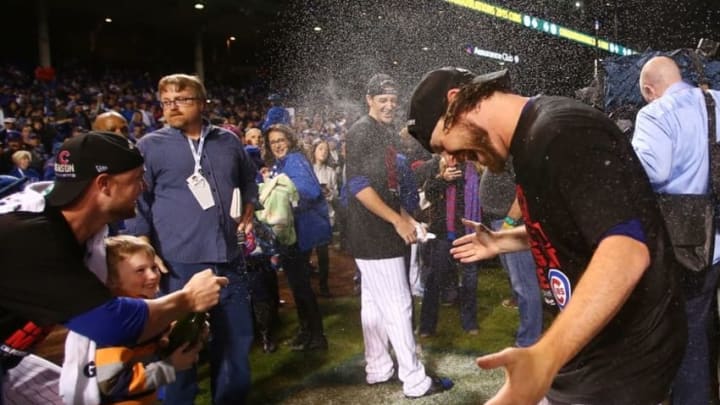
[{"left": 418, "top": 239, "right": 478, "bottom": 334}]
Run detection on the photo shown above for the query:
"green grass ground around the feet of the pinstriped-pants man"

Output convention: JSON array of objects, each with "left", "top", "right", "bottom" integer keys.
[{"left": 196, "top": 269, "right": 518, "bottom": 405}]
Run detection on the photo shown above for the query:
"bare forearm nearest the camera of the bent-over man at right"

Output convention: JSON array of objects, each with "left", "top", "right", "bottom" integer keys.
[{"left": 532, "top": 236, "right": 650, "bottom": 375}]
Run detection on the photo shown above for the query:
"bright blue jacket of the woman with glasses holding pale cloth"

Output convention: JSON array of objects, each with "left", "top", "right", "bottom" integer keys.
[{"left": 273, "top": 152, "right": 332, "bottom": 252}]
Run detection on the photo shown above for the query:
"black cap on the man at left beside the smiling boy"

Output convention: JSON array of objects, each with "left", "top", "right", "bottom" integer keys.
[{"left": 47, "top": 131, "right": 143, "bottom": 207}]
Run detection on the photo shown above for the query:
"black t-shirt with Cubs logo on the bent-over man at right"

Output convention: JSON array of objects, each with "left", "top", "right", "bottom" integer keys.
[{"left": 510, "top": 97, "right": 687, "bottom": 405}]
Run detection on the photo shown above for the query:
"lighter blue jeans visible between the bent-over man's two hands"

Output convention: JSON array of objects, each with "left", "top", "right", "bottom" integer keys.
[{"left": 492, "top": 219, "right": 543, "bottom": 347}]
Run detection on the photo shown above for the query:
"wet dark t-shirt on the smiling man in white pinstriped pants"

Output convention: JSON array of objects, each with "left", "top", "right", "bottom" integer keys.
[{"left": 346, "top": 115, "right": 407, "bottom": 259}]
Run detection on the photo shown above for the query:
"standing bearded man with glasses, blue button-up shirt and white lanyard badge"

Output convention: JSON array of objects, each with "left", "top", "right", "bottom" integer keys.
[{"left": 127, "top": 74, "right": 257, "bottom": 405}]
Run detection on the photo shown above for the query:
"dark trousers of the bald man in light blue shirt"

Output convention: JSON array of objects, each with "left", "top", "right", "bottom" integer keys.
[{"left": 671, "top": 264, "right": 720, "bottom": 405}]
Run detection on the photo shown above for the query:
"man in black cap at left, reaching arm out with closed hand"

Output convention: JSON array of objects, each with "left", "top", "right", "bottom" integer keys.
[{"left": 0, "top": 132, "right": 227, "bottom": 398}]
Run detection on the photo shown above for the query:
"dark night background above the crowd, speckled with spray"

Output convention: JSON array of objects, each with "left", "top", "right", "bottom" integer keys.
[{"left": 0, "top": 0, "right": 720, "bottom": 103}]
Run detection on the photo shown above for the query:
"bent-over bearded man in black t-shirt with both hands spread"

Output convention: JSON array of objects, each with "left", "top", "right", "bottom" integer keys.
[{"left": 408, "top": 68, "right": 686, "bottom": 405}]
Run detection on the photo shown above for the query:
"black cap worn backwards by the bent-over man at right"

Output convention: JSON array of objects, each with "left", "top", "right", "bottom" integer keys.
[{"left": 407, "top": 67, "right": 511, "bottom": 152}]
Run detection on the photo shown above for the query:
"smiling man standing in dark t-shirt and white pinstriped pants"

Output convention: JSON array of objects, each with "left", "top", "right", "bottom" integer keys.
[{"left": 347, "top": 74, "right": 452, "bottom": 398}]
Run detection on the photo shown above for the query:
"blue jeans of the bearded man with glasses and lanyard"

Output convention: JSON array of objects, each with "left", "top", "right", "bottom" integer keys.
[{"left": 161, "top": 259, "right": 253, "bottom": 405}]
